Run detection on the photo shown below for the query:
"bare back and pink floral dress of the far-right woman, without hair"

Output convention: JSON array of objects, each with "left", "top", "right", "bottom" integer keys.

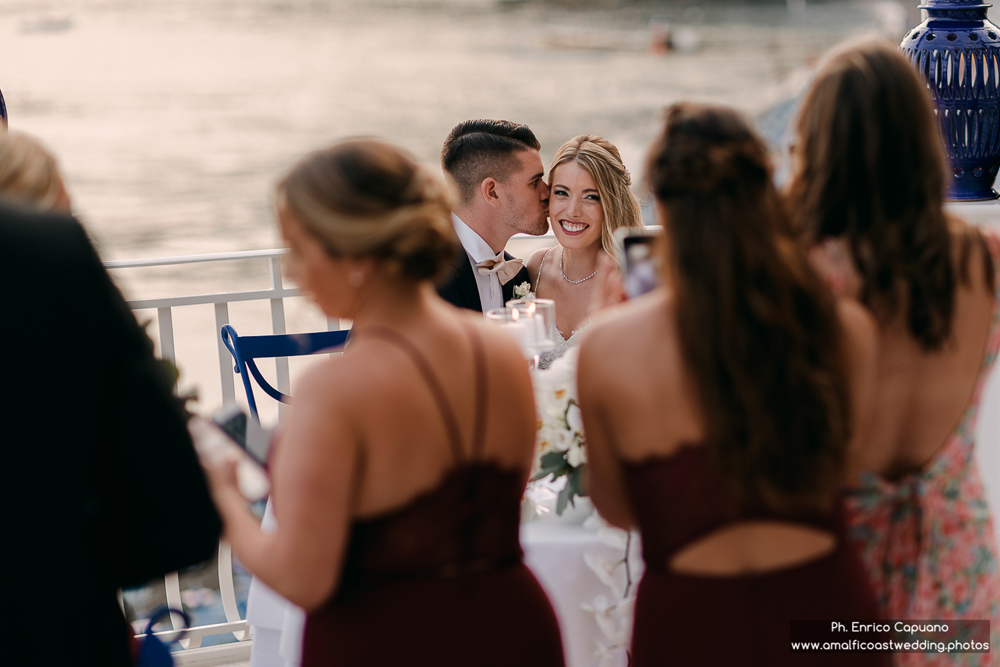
[{"left": 847, "top": 229, "right": 1000, "bottom": 640}]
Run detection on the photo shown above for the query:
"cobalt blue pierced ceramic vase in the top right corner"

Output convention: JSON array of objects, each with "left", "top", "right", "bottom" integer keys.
[{"left": 899, "top": 0, "right": 1000, "bottom": 201}]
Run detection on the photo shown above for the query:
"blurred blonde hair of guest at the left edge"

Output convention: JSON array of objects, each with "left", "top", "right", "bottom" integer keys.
[{"left": 0, "top": 128, "right": 72, "bottom": 213}]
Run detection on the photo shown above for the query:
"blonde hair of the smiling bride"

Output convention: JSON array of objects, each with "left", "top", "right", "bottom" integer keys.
[{"left": 549, "top": 134, "right": 643, "bottom": 258}]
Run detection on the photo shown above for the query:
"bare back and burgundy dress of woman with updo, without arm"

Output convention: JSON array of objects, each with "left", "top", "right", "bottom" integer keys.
[{"left": 303, "top": 306, "right": 562, "bottom": 667}]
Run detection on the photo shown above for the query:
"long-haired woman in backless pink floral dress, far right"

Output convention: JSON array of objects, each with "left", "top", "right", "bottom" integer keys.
[{"left": 790, "top": 37, "right": 1000, "bottom": 640}]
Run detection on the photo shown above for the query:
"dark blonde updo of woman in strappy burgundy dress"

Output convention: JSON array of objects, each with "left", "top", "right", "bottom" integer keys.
[{"left": 277, "top": 139, "right": 458, "bottom": 280}]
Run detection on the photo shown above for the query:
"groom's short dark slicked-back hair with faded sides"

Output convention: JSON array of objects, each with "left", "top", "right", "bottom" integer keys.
[{"left": 441, "top": 119, "right": 542, "bottom": 204}]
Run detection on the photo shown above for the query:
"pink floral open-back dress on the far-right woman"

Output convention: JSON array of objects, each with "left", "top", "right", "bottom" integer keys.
[{"left": 847, "top": 231, "right": 1000, "bottom": 666}]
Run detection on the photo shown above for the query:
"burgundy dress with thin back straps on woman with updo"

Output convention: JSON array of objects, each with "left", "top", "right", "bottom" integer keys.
[{"left": 302, "top": 327, "right": 563, "bottom": 667}]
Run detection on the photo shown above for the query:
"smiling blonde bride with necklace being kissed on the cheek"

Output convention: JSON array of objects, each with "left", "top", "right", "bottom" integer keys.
[{"left": 528, "top": 134, "right": 643, "bottom": 368}]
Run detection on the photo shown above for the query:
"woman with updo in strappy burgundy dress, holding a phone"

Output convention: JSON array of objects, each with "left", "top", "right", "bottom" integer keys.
[{"left": 205, "top": 140, "right": 563, "bottom": 667}]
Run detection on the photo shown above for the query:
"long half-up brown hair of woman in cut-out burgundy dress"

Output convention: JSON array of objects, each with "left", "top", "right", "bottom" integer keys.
[{"left": 646, "top": 104, "right": 850, "bottom": 513}]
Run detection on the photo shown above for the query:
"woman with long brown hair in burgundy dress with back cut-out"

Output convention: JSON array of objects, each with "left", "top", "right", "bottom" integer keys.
[{"left": 579, "top": 105, "right": 888, "bottom": 667}]
